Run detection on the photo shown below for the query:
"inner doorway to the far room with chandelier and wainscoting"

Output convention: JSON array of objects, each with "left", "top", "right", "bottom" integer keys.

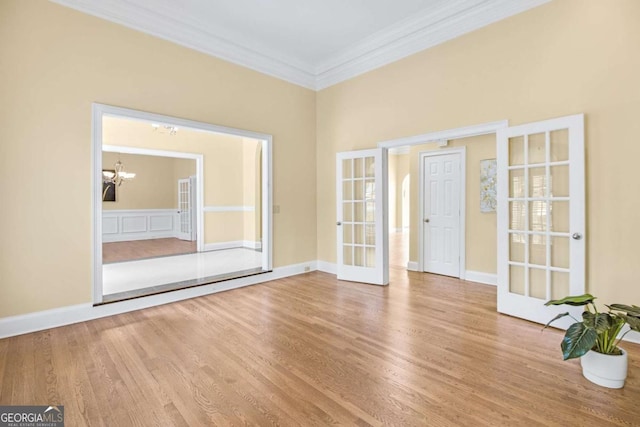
[{"left": 102, "top": 150, "right": 198, "bottom": 265}]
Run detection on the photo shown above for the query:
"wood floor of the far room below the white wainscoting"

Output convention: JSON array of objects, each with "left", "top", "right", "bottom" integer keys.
[{"left": 102, "top": 237, "right": 196, "bottom": 264}]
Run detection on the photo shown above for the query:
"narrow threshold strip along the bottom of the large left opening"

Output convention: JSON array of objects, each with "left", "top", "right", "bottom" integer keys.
[{"left": 93, "top": 267, "right": 269, "bottom": 307}]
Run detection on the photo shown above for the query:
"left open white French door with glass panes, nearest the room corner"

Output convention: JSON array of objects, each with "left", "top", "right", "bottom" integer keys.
[{"left": 336, "top": 148, "right": 389, "bottom": 285}]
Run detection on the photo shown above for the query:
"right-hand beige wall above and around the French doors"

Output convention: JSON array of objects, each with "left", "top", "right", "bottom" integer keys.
[{"left": 317, "top": 0, "right": 640, "bottom": 303}]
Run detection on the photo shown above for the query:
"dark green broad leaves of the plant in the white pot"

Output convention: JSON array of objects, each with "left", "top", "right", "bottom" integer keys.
[{"left": 544, "top": 294, "right": 640, "bottom": 360}]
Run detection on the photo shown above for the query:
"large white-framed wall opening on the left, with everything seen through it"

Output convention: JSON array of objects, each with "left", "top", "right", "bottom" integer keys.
[{"left": 93, "top": 104, "right": 272, "bottom": 304}]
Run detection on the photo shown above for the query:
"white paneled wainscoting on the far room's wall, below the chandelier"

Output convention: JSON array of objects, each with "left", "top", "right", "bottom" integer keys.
[{"left": 102, "top": 209, "right": 179, "bottom": 243}]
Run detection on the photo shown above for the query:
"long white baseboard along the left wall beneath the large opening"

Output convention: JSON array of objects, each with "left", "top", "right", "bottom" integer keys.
[{"left": 0, "top": 261, "right": 317, "bottom": 339}]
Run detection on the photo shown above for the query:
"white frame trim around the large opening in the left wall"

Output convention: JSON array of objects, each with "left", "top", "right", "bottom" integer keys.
[{"left": 91, "top": 103, "right": 273, "bottom": 304}]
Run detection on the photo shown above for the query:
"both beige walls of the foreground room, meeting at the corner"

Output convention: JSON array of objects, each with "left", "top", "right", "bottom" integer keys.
[{"left": 0, "top": 0, "right": 640, "bottom": 317}]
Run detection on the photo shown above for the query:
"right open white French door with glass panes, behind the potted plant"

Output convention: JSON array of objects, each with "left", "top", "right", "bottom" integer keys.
[{"left": 497, "top": 115, "right": 585, "bottom": 323}]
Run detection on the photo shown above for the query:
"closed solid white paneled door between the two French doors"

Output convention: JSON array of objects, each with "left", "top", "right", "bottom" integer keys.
[{"left": 421, "top": 152, "right": 461, "bottom": 277}]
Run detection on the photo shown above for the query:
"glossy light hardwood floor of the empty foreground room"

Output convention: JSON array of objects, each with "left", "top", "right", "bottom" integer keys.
[{"left": 0, "top": 236, "right": 640, "bottom": 426}]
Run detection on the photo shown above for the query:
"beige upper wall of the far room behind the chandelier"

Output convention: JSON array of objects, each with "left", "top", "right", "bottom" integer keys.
[{"left": 102, "top": 152, "right": 195, "bottom": 210}]
